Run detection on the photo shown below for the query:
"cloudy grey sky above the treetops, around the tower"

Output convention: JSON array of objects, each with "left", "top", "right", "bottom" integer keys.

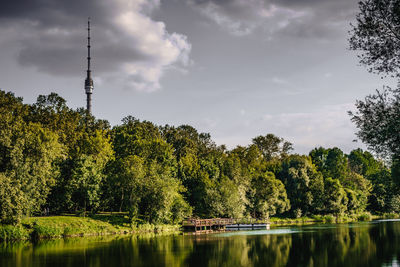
[{"left": 0, "top": 0, "right": 392, "bottom": 154}]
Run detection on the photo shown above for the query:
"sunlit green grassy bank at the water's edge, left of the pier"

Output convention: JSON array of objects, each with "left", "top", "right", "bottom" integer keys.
[{"left": 0, "top": 214, "right": 180, "bottom": 242}]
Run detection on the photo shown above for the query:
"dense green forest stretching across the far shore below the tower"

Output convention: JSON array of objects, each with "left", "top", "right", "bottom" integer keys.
[{"left": 0, "top": 91, "right": 400, "bottom": 224}]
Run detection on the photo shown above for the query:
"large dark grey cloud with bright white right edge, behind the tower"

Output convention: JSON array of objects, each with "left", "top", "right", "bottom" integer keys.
[{"left": 0, "top": 0, "right": 191, "bottom": 91}]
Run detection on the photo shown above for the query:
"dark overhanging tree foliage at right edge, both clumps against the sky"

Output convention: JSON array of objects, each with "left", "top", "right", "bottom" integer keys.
[{"left": 349, "top": 0, "right": 400, "bottom": 159}]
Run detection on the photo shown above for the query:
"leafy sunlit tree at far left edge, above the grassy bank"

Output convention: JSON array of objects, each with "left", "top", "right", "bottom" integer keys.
[{"left": 0, "top": 123, "right": 64, "bottom": 223}]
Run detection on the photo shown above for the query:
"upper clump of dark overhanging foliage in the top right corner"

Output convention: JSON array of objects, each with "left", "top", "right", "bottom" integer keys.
[{"left": 349, "top": 0, "right": 400, "bottom": 77}]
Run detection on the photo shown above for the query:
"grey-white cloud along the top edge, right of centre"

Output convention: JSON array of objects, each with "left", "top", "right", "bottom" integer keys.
[{"left": 184, "top": 0, "right": 356, "bottom": 39}]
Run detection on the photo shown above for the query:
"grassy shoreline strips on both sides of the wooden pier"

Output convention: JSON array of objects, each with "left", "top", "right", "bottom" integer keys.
[{"left": 0, "top": 213, "right": 399, "bottom": 244}]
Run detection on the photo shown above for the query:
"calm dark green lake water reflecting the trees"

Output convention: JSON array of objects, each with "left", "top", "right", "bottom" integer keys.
[{"left": 0, "top": 220, "right": 400, "bottom": 267}]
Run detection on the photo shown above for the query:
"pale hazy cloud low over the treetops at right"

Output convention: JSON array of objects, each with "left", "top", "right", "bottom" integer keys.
[{"left": 215, "top": 104, "right": 365, "bottom": 154}]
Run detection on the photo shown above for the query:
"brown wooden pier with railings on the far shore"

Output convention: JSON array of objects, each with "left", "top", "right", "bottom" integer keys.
[{"left": 182, "top": 218, "right": 270, "bottom": 233}]
